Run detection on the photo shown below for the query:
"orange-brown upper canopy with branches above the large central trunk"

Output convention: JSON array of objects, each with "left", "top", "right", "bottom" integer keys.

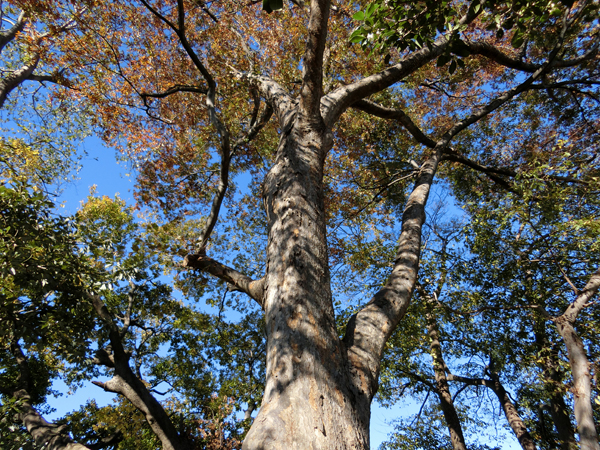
[{"left": 14, "top": 0, "right": 600, "bottom": 270}]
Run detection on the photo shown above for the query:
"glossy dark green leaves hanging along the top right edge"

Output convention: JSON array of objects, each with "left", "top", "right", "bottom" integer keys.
[{"left": 350, "top": 0, "right": 599, "bottom": 74}]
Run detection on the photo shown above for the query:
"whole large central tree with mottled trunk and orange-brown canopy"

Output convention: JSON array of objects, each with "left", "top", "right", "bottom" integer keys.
[{"left": 19, "top": 0, "right": 600, "bottom": 450}]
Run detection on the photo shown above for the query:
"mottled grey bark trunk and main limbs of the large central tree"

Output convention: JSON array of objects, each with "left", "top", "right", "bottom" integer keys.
[{"left": 178, "top": 0, "right": 576, "bottom": 450}]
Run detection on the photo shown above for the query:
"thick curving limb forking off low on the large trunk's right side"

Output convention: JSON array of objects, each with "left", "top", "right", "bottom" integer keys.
[{"left": 342, "top": 34, "right": 562, "bottom": 395}]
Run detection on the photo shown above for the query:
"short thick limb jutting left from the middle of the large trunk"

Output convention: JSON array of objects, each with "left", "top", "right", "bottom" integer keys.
[{"left": 183, "top": 254, "right": 264, "bottom": 308}]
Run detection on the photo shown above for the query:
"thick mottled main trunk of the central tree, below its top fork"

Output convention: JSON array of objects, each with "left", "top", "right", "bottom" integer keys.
[{"left": 243, "top": 119, "right": 371, "bottom": 450}]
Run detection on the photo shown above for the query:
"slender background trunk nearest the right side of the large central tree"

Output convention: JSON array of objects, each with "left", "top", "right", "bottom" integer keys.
[{"left": 427, "top": 312, "right": 467, "bottom": 450}]
